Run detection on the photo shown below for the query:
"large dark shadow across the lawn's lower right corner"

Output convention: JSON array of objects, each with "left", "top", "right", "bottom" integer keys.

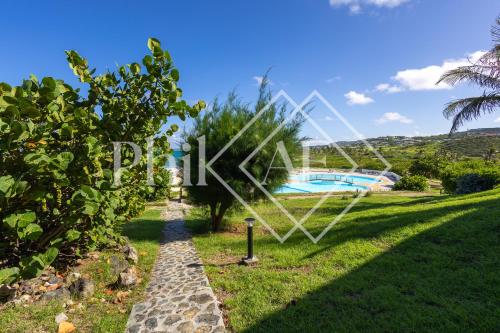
[{"left": 241, "top": 198, "right": 500, "bottom": 332}]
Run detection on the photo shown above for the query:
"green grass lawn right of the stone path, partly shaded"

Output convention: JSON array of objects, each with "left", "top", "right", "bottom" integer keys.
[{"left": 188, "top": 189, "right": 500, "bottom": 332}]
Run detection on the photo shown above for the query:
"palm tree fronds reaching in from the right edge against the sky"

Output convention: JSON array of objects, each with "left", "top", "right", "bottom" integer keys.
[{"left": 436, "top": 16, "right": 500, "bottom": 134}]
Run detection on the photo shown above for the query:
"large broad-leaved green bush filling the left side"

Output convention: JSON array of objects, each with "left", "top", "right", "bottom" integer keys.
[{"left": 0, "top": 38, "right": 204, "bottom": 284}]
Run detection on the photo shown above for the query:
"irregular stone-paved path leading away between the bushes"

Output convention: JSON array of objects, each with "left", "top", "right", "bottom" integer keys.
[{"left": 126, "top": 202, "right": 225, "bottom": 333}]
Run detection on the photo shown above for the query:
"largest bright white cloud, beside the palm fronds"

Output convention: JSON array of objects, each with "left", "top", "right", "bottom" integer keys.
[{"left": 392, "top": 51, "right": 485, "bottom": 90}]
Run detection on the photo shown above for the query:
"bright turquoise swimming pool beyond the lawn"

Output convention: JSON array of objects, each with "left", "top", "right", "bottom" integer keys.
[{"left": 275, "top": 173, "right": 379, "bottom": 194}]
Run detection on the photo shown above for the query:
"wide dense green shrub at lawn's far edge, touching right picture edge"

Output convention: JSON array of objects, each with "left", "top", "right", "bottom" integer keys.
[{"left": 441, "top": 160, "right": 500, "bottom": 193}]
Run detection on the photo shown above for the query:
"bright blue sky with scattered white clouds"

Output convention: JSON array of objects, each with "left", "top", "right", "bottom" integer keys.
[{"left": 0, "top": 0, "right": 500, "bottom": 140}]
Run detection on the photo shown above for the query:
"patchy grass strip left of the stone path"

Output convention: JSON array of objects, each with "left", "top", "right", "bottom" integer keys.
[{"left": 0, "top": 209, "right": 163, "bottom": 333}]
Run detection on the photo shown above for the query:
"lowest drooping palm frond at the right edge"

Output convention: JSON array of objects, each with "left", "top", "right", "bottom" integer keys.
[{"left": 443, "top": 91, "right": 500, "bottom": 134}]
